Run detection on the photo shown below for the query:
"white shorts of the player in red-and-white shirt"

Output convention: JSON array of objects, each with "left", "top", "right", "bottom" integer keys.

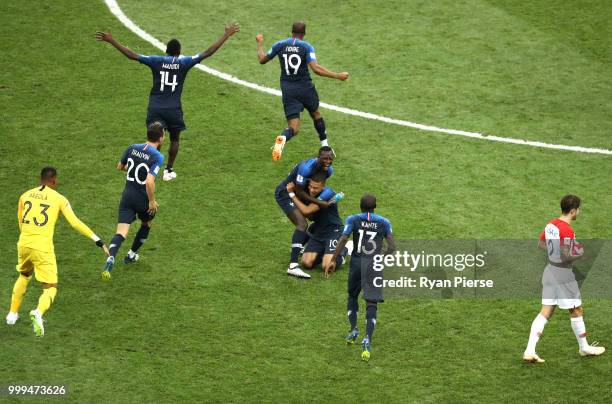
[{"left": 542, "top": 264, "right": 582, "bottom": 309}]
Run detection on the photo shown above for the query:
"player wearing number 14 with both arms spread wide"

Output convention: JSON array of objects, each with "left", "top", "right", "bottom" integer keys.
[{"left": 95, "top": 23, "right": 240, "bottom": 181}]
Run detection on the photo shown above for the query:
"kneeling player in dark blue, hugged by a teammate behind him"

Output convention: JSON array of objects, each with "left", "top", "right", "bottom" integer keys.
[{"left": 287, "top": 171, "right": 353, "bottom": 269}]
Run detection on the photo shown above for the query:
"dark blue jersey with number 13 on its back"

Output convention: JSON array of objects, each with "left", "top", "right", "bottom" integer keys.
[{"left": 342, "top": 212, "right": 393, "bottom": 257}]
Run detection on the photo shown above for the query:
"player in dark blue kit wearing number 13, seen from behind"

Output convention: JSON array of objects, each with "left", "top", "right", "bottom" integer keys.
[{"left": 325, "top": 194, "right": 395, "bottom": 361}]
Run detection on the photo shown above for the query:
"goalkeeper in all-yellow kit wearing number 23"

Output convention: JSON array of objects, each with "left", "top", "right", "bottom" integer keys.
[{"left": 6, "top": 167, "right": 108, "bottom": 337}]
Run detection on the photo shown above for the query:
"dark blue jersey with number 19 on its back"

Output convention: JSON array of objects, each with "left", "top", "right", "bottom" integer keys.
[{"left": 268, "top": 38, "right": 317, "bottom": 83}]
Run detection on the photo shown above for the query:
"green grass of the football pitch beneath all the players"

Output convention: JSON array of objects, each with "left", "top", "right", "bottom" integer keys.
[{"left": 0, "top": 0, "right": 612, "bottom": 402}]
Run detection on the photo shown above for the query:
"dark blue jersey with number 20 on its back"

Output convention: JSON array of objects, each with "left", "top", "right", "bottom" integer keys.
[{"left": 121, "top": 143, "right": 164, "bottom": 195}]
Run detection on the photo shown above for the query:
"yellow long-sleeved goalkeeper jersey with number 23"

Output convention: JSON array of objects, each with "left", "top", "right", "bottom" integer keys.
[{"left": 17, "top": 185, "right": 98, "bottom": 251}]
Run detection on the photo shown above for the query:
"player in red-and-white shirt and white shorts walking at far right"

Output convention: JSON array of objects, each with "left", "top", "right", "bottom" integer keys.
[{"left": 523, "top": 195, "right": 606, "bottom": 363}]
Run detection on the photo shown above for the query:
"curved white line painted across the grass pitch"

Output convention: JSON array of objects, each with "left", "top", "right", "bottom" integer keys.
[{"left": 104, "top": 0, "right": 612, "bottom": 155}]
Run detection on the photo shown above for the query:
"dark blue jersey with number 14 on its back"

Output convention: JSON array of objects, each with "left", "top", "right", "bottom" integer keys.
[{"left": 138, "top": 54, "right": 203, "bottom": 108}]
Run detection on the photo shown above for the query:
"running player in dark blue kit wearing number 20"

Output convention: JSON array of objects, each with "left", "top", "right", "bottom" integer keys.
[{"left": 102, "top": 122, "right": 164, "bottom": 279}]
